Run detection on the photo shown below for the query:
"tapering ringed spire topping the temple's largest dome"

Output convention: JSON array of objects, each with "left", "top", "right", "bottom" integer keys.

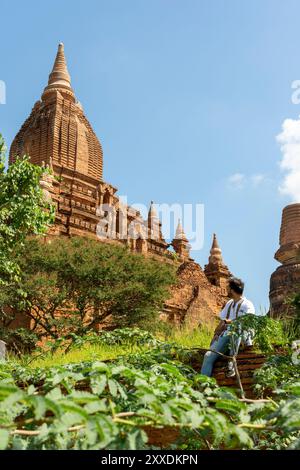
[{"left": 44, "top": 42, "right": 74, "bottom": 96}]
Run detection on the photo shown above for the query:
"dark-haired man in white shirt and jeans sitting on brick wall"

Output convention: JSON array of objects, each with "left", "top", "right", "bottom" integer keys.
[{"left": 201, "top": 278, "right": 255, "bottom": 377}]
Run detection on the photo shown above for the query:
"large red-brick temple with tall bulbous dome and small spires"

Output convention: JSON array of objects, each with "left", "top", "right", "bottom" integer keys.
[{"left": 9, "top": 43, "right": 230, "bottom": 325}]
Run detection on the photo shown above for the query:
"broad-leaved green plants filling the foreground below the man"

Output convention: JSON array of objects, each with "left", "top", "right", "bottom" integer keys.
[{"left": 0, "top": 329, "right": 300, "bottom": 449}]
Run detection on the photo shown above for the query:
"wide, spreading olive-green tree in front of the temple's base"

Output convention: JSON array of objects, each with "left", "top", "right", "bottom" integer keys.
[{"left": 0, "top": 237, "right": 175, "bottom": 346}]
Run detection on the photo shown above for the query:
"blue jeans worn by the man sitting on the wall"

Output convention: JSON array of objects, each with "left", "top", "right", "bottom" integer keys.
[{"left": 201, "top": 335, "right": 242, "bottom": 377}]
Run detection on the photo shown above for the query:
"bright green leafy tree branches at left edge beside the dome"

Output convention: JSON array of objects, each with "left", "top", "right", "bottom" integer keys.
[{"left": 0, "top": 134, "right": 54, "bottom": 285}]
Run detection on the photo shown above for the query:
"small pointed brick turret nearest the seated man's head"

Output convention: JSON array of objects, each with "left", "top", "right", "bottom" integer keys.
[{"left": 204, "top": 233, "right": 231, "bottom": 296}]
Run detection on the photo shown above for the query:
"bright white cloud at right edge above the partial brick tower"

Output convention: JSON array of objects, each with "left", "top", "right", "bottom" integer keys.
[{"left": 276, "top": 119, "right": 300, "bottom": 202}]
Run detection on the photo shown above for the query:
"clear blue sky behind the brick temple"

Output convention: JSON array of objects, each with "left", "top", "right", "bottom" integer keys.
[{"left": 0, "top": 0, "right": 300, "bottom": 309}]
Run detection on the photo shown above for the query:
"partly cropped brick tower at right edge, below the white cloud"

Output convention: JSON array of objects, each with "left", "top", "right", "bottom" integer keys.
[{"left": 270, "top": 203, "right": 300, "bottom": 318}]
